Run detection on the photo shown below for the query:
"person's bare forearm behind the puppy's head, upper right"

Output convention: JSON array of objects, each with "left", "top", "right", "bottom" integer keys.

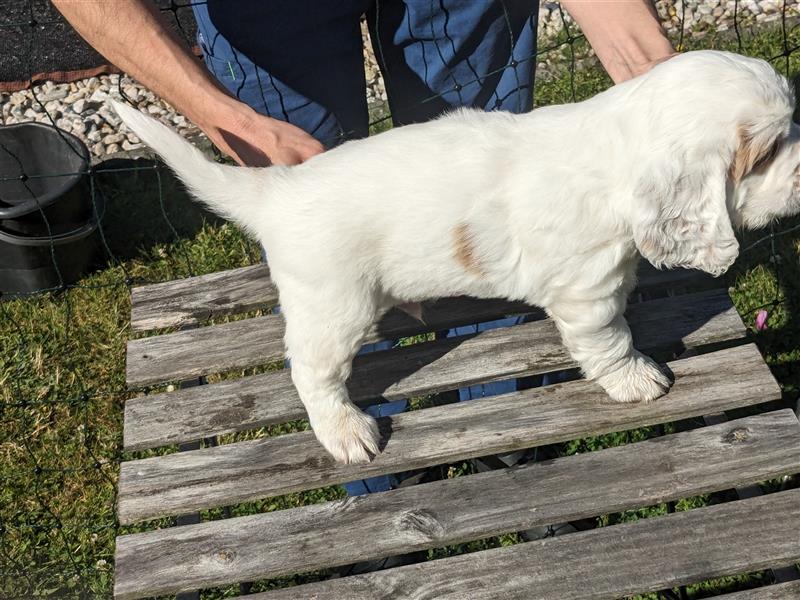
[{"left": 561, "top": 0, "right": 676, "bottom": 83}]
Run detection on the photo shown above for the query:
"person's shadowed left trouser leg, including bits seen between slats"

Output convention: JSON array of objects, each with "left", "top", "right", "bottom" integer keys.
[{"left": 193, "top": 0, "right": 407, "bottom": 496}]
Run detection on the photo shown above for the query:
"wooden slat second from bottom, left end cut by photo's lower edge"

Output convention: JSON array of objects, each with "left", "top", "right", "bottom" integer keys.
[{"left": 247, "top": 490, "right": 800, "bottom": 600}]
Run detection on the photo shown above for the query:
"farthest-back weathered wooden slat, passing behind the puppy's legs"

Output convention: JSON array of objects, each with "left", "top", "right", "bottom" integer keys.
[{"left": 131, "top": 261, "right": 713, "bottom": 331}]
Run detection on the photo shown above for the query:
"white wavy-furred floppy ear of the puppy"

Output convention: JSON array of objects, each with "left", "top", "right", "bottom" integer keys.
[{"left": 632, "top": 148, "right": 739, "bottom": 276}]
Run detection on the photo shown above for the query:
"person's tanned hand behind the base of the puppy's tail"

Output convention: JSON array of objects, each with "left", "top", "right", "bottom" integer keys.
[{"left": 196, "top": 102, "right": 325, "bottom": 167}]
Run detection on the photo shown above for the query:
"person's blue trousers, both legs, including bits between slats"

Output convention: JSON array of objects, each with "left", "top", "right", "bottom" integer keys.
[{"left": 193, "top": 0, "right": 539, "bottom": 495}]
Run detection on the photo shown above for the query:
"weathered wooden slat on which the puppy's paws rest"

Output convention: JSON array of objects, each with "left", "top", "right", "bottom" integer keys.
[{"left": 118, "top": 345, "right": 780, "bottom": 524}]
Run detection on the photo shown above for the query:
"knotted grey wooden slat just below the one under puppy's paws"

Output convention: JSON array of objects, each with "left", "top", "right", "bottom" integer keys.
[{"left": 115, "top": 410, "right": 800, "bottom": 599}]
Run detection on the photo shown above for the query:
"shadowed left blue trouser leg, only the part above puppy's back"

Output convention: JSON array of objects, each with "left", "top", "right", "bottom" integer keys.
[{"left": 192, "top": 0, "right": 368, "bottom": 148}]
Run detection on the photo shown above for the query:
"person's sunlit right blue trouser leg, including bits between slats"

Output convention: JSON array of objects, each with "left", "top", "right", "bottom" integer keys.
[{"left": 368, "top": 0, "right": 539, "bottom": 400}]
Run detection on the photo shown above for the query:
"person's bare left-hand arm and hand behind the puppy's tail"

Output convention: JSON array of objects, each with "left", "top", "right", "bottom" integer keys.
[{"left": 53, "top": 0, "right": 324, "bottom": 166}]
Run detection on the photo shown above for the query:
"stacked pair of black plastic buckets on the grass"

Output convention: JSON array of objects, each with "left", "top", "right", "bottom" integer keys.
[{"left": 0, "top": 123, "right": 97, "bottom": 296}]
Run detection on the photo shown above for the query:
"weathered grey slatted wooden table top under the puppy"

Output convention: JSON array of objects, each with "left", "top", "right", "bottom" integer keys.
[{"left": 115, "top": 266, "right": 800, "bottom": 599}]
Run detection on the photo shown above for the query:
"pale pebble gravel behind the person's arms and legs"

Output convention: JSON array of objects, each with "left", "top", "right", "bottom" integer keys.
[{"left": 0, "top": 0, "right": 800, "bottom": 160}]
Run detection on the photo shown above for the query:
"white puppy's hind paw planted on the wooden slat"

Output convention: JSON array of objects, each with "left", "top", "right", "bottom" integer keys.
[{"left": 312, "top": 403, "right": 381, "bottom": 464}]
